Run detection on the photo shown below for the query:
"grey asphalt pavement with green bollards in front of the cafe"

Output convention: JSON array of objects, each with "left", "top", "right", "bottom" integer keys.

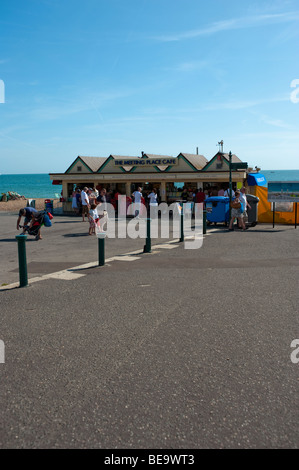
[{"left": 0, "top": 214, "right": 299, "bottom": 449}]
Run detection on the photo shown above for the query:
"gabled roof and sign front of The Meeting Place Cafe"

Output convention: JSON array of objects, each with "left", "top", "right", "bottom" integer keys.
[{"left": 50, "top": 151, "right": 247, "bottom": 213}]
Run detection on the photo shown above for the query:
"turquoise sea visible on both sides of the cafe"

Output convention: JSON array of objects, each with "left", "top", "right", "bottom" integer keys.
[{"left": 0, "top": 170, "right": 299, "bottom": 199}]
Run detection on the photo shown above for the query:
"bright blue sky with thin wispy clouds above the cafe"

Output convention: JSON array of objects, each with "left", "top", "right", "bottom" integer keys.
[{"left": 0, "top": 0, "right": 299, "bottom": 174}]
